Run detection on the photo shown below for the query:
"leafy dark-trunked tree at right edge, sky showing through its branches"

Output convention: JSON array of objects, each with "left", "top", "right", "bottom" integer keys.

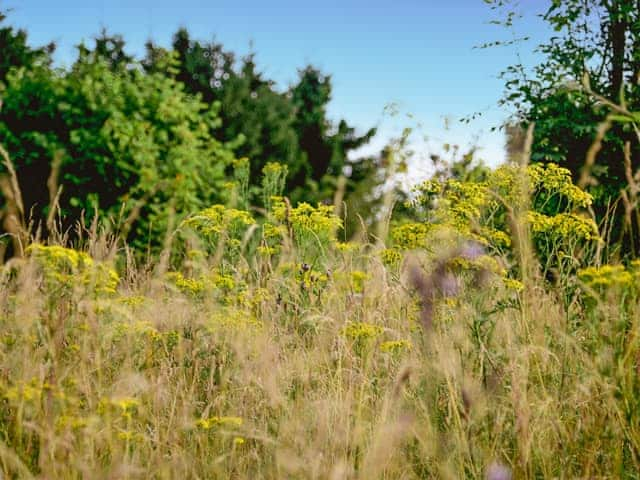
[{"left": 488, "top": 0, "right": 640, "bottom": 255}]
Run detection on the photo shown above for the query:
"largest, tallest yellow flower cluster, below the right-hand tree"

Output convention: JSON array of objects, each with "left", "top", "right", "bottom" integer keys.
[{"left": 404, "top": 163, "right": 600, "bottom": 274}]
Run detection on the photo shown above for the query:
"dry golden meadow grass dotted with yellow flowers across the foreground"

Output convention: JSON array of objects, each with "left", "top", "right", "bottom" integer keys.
[{"left": 0, "top": 214, "right": 640, "bottom": 479}]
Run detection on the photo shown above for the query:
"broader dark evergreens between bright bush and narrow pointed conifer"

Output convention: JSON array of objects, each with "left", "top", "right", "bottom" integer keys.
[{"left": 145, "top": 29, "right": 301, "bottom": 189}]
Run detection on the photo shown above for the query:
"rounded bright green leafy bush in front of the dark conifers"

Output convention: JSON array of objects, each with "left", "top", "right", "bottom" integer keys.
[{"left": 0, "top": 39, "right": 233, "bottom": 246}]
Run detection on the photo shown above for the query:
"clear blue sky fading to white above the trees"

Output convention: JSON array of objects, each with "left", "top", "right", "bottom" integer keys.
[{"left": 0, "top": 0, "right": 547, "bottom": 175}]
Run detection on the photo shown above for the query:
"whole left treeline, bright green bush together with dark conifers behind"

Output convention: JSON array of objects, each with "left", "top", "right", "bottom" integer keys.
[{"left": 0, "top": 10, "right": 390, "bottom": 251}]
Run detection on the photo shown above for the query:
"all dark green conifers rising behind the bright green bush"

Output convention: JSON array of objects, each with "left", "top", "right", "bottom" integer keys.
[{"left": 144, "top": 29, "right": 375, "bottom": 206}]
